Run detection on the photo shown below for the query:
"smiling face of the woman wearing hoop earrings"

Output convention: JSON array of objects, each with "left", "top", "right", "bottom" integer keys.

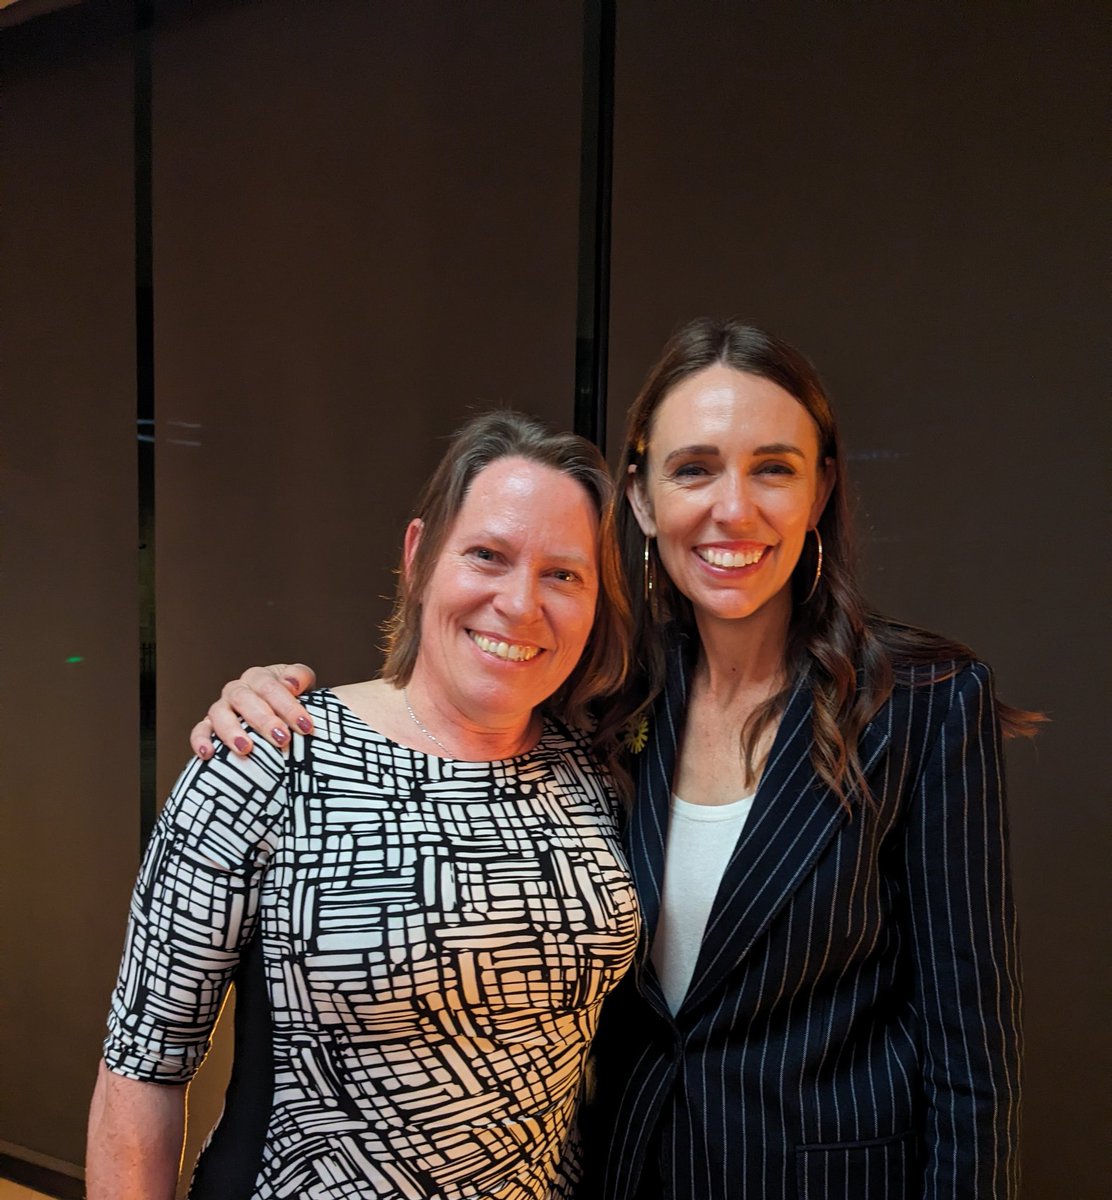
[{"left": 627, "top": 364, "right": 834, "bottom": 638}]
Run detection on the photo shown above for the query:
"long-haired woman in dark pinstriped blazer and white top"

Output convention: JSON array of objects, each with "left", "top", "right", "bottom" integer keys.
[{"left": 194, "top": 320, "right": 1039, "bottom": 1200}]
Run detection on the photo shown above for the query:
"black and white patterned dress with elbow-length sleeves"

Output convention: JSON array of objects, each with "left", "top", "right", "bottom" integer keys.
[{"left": 104, "top": 691, "right": 638, "bottom": 1200}]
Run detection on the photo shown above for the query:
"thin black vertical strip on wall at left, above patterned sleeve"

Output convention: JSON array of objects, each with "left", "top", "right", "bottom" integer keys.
[{"left": 134, "top": 0, "right": 157, "bottom": 846}]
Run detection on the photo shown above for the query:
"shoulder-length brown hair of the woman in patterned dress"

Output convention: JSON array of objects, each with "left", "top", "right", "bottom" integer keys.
[{"left": 383, "top": 410, "right": 631, "bottom": 728}]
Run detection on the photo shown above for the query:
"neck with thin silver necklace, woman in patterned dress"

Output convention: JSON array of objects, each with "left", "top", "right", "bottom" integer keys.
[{"left": 396, "top": 668, "right": 541, "bottom": 762}]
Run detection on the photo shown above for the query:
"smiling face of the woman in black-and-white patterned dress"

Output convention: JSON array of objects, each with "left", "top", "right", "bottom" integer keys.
[{"left": 404, "top": 457, "right": 599, "bottom": 730}]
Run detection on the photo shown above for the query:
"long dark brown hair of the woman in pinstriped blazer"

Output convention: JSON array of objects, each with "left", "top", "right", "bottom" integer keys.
[{"left": 607, "top": 318, "right": 1044, "bottom": 803}]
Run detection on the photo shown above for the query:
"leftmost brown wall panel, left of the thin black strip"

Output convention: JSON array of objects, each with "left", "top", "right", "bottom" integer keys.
[{"left": 0, "top": 2, "right": 139, "bottom": 1180}]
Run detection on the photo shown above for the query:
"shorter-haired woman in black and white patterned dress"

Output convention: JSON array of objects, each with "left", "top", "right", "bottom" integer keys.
[{"left": 86, "top": 413, "right": 638, "bottom": 1200}]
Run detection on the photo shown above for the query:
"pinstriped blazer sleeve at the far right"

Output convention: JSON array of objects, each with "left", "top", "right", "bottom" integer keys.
[{"left": 904, "top": 662, "right": 1020, "bottom": 1200}]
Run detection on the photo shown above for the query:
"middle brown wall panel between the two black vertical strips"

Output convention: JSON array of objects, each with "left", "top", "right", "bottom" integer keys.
[{"left": 154, "top": 0, "right": 582, "bottom": 1180}]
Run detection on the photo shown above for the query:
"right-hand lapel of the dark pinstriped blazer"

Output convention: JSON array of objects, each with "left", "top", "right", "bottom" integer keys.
[{"left": 683, "top": 680, "right": 888, "bottom": 1008}]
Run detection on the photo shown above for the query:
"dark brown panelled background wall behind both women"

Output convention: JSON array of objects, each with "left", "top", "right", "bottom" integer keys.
[{"left": 0, "top": 0, "right": 1112, "bottom": 1200}]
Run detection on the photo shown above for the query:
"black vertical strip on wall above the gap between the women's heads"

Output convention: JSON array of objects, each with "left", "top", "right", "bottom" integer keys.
[{"left": 575, "top": 0, "right": 614, "bottom": 452}]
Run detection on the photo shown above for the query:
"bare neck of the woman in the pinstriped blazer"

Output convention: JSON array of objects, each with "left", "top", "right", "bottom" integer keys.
[{"left": 695, "top": 590, "right": 792, "bottom": 704}]
